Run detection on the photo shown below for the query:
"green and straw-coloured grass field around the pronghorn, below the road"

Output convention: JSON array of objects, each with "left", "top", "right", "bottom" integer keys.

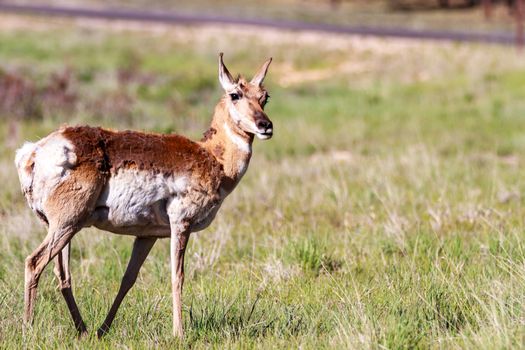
[{"left": 0, "top": 16, "right": 525, "bottom": 349}]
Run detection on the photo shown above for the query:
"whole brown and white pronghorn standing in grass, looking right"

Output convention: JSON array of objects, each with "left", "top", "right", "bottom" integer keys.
[{"left": 15, "top": 53, "right": 273, "bottom": 338}]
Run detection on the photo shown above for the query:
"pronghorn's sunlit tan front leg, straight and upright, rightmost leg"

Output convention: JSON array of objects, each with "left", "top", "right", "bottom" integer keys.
[{"left": 170, "top": 224, "right": 190, "bottom": 338}]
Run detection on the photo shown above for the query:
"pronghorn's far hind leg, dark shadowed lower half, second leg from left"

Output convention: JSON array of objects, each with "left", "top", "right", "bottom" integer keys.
[{"left": 54, "top": 242, "right": 87, "bottom": 336}]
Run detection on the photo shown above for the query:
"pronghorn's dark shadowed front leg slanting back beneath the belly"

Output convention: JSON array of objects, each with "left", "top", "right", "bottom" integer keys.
[{"left": 97, "top": 237, "right": 157, "bottom": 338}]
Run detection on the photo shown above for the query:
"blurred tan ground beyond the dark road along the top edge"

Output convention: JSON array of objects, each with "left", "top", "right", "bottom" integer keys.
[{"left": 3, "top": 0, "right": 520, "bottom": 32}]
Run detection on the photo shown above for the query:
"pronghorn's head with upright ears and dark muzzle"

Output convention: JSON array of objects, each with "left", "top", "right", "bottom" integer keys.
[{"left": 219, "top": 53, "right": 273, "bottom": 140}]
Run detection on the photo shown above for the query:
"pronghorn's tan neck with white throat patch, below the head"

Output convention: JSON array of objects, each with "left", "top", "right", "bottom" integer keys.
[{"left": 200, "top": 100, "right": 253, "bottom": 193}]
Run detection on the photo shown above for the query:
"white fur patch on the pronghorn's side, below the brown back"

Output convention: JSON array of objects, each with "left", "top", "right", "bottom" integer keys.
[{"left": 97, "top": 169, "right": 189, "bottom": 226}]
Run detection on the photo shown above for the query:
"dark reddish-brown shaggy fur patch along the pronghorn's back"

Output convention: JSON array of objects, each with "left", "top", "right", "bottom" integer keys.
[{"left": 61, "top": 126, "right": 224, "bottom": 197}]
